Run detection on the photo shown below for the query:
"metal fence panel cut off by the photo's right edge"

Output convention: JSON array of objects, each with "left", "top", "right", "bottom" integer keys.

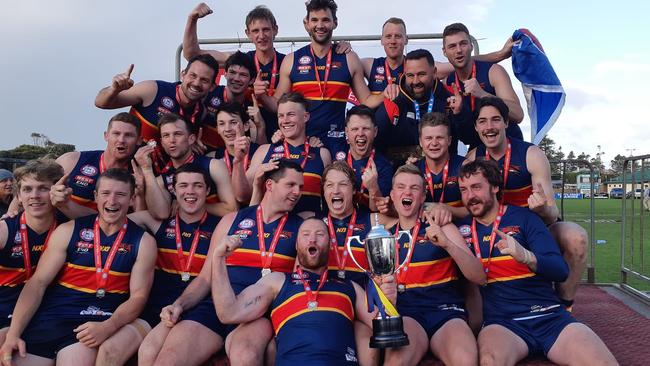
[{"left": 620, "top": 155, "right": 650, "bottom": 301}]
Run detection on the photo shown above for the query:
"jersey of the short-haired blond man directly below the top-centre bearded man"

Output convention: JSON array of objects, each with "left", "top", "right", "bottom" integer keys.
[{"left": 262, "top": 143, "right": 325, "bottom": 213}]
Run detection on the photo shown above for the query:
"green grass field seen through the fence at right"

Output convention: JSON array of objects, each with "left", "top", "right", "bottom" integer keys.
[{"left": 557, "top": 199, "right": 650, "bottom": 291}]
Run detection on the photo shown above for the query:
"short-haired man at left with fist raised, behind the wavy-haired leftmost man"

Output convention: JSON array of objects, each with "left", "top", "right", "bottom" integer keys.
[{"left": 51, "top": 112, "right": 141, "bottom": 219}]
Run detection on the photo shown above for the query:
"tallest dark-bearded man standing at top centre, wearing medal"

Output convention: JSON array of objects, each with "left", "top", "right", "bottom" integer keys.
[{"left": 262, "top": 0, "right": 383, "bottom": 153}]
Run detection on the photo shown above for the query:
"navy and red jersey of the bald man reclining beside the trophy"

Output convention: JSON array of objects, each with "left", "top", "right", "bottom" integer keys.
[{"left": 271, "top": 271, "right": 357, "bottom": 366}]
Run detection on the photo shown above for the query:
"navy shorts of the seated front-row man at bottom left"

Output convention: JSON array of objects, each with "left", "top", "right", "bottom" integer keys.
[{"left": 21, "top": 319, "right": 86, "bottom": 360}]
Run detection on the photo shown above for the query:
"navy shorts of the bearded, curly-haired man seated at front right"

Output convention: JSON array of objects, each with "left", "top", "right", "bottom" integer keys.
[{"left": 484, "top": 309, "right": 578, "bottom": 356}]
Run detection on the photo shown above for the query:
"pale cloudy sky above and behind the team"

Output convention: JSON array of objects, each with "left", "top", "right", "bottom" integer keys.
[{"left": 0, "top": 0, "right": 650, "bottom": 167}]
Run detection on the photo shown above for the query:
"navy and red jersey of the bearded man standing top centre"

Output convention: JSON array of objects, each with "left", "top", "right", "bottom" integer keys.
[{"left": 289, "top": 45, "right": 352, "bottom": 151}]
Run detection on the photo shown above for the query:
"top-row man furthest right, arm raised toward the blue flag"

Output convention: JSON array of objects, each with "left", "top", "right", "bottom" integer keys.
[{"left": 442, "top": 23, "right": 524, "bottom": 149}]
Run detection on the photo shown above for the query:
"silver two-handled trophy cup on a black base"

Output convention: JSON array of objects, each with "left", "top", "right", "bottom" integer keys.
[{"left": 345, "top": 214, "right": 413, "bottom": 348}]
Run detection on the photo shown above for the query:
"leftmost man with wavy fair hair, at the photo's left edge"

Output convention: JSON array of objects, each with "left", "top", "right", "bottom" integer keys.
[{"left": 0, "top": 159, "right": 63, "bottom": 343}]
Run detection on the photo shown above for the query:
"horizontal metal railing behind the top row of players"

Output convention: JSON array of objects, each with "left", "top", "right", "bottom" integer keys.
[{"left": 176, "top": 33, "right": 479, "bottom": 81}]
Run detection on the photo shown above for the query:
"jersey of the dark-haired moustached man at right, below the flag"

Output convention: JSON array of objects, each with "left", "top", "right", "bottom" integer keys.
[{"left": 475, "top": 139, "right": 534, "bottom": 207}]
